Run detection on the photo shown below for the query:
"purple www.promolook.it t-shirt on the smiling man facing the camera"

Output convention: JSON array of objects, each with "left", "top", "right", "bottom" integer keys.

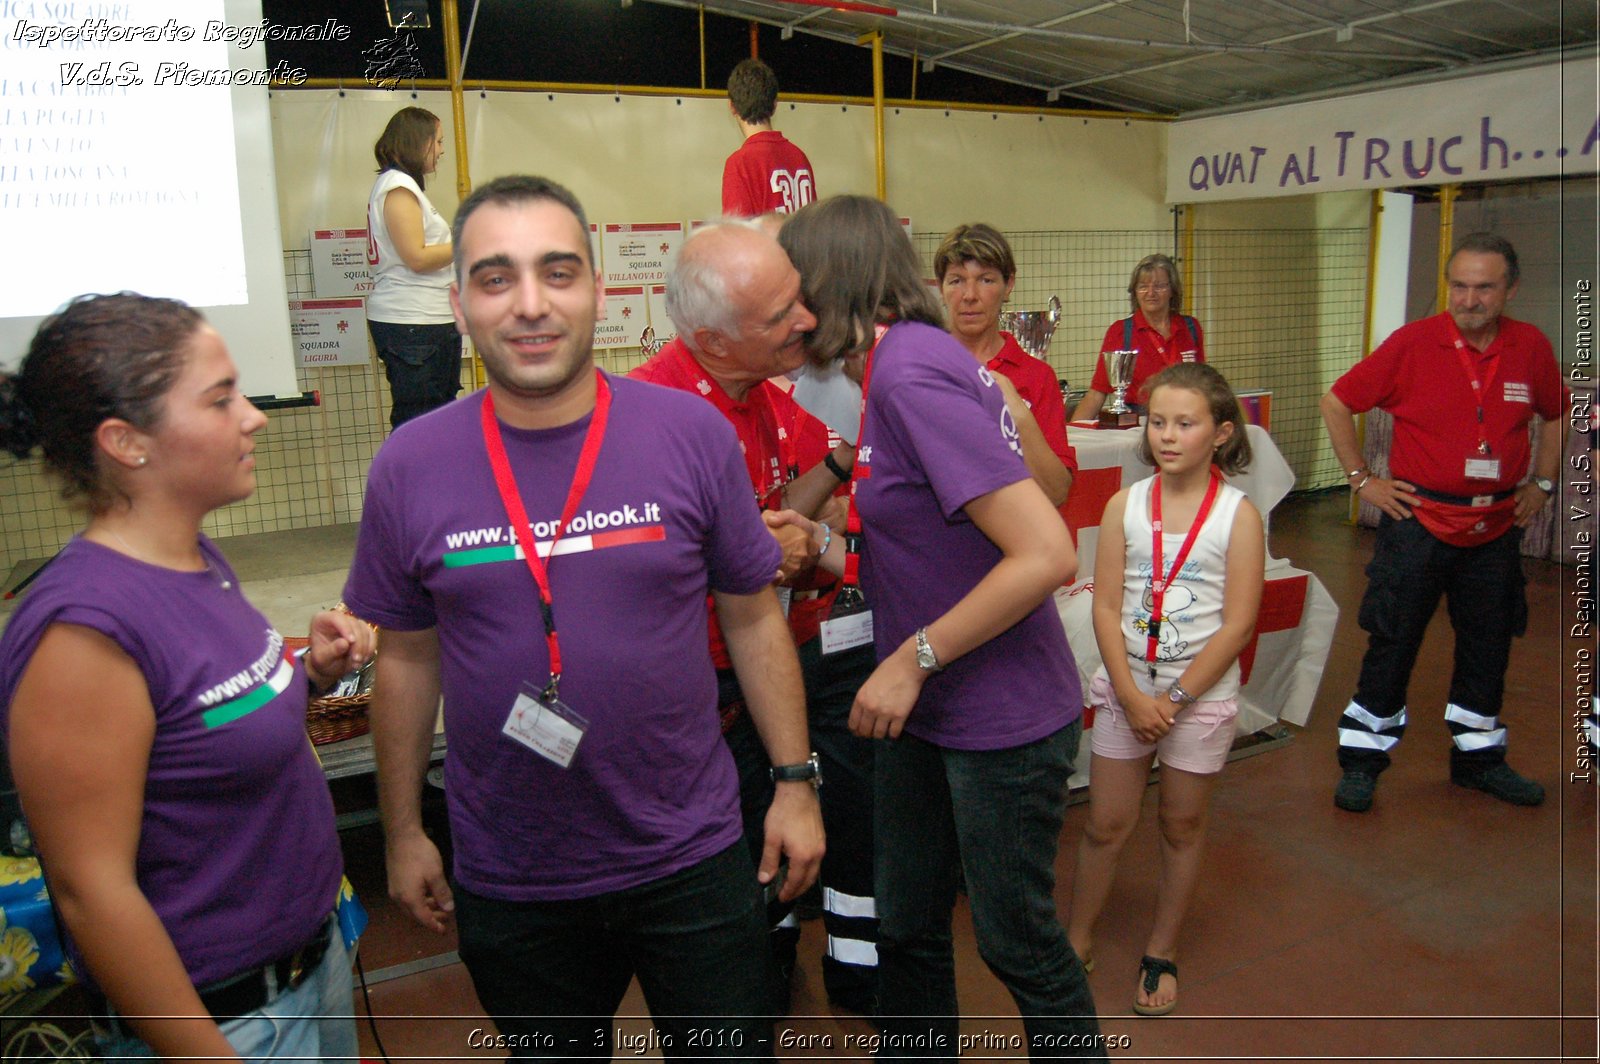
[{"left": 344, "top": 374, "right": 781, "bottom": 901}]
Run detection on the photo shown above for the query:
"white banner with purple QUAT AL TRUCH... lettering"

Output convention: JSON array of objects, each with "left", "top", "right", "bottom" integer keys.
[{"left": 1166, "top": 56, "right": 1600, "bottom": 203}]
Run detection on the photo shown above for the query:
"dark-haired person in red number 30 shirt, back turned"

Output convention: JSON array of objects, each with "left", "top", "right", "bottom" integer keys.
[{"left": 722, "top": 59, "right": 816, "bottom": 218}]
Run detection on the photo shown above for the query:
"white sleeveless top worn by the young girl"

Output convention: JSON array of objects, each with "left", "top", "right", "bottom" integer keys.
[{"left": 1122, "top": 477, "right": 1245, "bottom": 702}]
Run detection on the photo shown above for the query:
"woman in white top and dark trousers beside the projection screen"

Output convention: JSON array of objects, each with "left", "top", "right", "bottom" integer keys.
[{"left": 366, "top": 107, "right": 461, "bottom": 427}]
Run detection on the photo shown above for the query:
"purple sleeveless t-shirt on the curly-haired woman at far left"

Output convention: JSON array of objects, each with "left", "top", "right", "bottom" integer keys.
[{"left": 0, "top": 538, "right": 342, "bottom": 986}]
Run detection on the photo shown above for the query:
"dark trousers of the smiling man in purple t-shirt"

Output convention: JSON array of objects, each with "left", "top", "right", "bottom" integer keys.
[{"left": 456, "top": 845, "right": 773, "bottom": 1061}]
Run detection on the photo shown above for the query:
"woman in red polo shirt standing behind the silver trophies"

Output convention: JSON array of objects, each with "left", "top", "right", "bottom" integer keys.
[{"left": 1072, "top": 253, "right": 1205, "bottom": 421}]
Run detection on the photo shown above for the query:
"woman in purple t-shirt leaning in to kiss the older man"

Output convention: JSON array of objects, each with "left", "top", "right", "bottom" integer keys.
[{"left": 773, "top": 197, "right": 1104, "bottom": 1058}]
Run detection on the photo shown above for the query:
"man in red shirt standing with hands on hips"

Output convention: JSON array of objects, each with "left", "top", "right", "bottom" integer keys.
[{"left": 1322, "top": 234, "right": 1568, "bottom": 813}]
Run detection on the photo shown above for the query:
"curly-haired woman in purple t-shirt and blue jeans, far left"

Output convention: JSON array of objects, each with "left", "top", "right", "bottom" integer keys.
[{"left": 0, "top": 293, "right": 371, "bottom": 1059}]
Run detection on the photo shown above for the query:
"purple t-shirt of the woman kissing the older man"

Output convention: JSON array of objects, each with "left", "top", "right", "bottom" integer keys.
[{"left": 856, "top": 322, "right": 1083, "bottom": 750}]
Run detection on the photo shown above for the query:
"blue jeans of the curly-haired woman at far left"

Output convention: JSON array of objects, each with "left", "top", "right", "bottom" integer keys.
[{"left": 94, "top": 923, "right": 360, "bottom": 1064}]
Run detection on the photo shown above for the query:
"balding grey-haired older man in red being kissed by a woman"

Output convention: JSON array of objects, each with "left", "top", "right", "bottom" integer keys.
[{"left": 630, "top": 221, "right": 877, "bottom": 1013}]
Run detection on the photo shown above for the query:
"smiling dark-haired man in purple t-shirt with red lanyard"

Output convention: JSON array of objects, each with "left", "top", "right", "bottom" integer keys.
[{"left": 346, "top": 178, "right": 822, "bottom": 1059}]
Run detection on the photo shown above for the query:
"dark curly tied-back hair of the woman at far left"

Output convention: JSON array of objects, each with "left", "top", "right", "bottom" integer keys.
[{"left": 0, "top": 291, "right": 205, "bottom": 514}]
